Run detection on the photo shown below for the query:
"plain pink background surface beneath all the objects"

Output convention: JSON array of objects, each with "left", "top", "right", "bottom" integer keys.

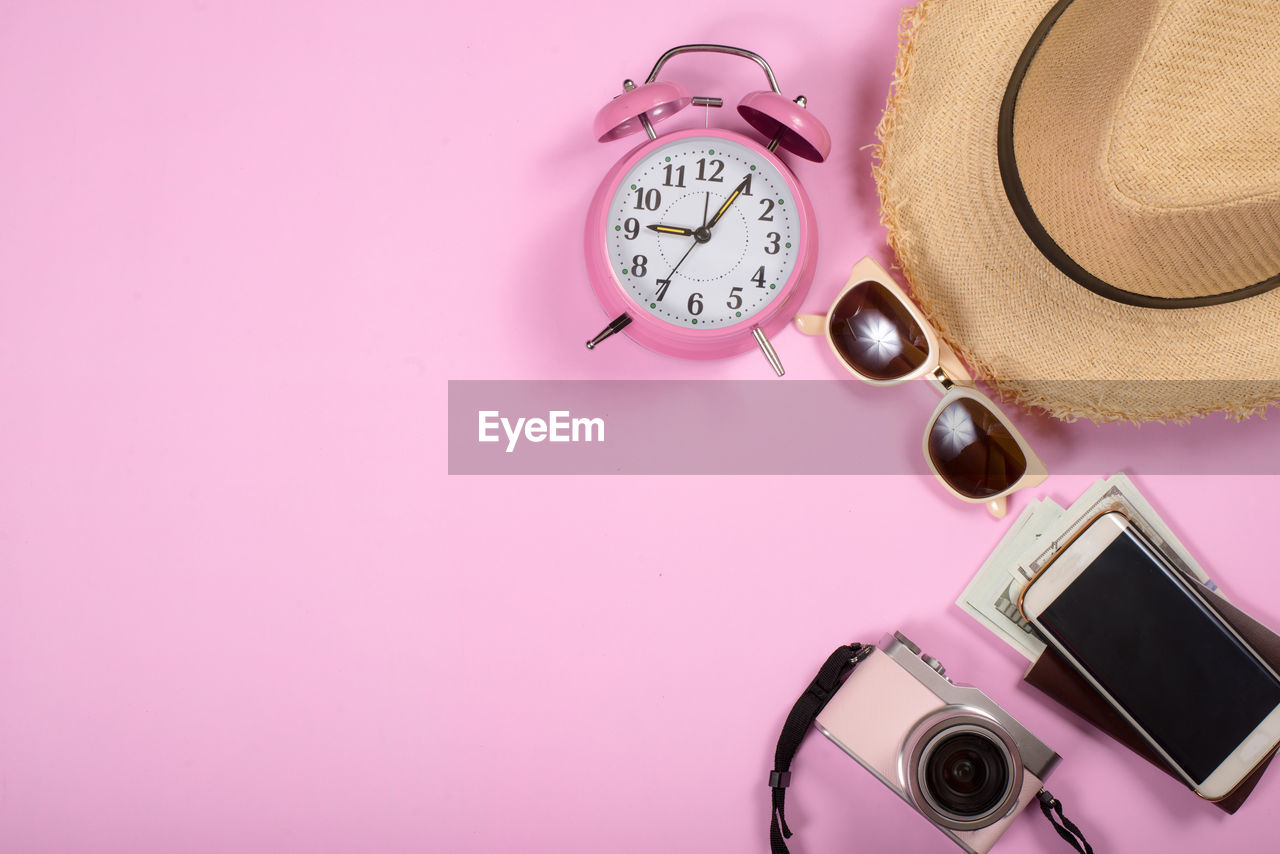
[{"left": 0, "top": 0, "right": 1280, "bottom": 854}]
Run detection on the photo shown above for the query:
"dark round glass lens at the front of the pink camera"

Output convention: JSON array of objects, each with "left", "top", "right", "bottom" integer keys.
[{"left": 924, "top": 731, "right": 1010, "bottom": 818}]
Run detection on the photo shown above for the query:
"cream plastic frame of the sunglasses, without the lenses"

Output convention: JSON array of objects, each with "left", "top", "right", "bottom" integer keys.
[{"left": 796, "top": 257, "right": 1048, "bottom": 519}]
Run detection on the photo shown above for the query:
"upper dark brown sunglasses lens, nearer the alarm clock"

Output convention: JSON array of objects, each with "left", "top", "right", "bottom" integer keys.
[{"left": 831, "top": 282, "right": 929, "bottom": 380}]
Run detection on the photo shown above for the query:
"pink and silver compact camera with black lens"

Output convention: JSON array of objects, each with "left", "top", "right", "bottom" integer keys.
[{"left": 815, "top": 632, "right": 1059, "bottom": 854}]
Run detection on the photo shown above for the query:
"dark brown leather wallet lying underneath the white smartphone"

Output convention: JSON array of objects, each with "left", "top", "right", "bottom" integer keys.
[{"left": 1023, "top": 589, "right": 1280, "bottom": 813}]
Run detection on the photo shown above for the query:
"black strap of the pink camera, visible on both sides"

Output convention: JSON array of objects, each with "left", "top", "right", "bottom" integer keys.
[{"left": 769, "top": 644, "right": 1093, "bottom": 854}]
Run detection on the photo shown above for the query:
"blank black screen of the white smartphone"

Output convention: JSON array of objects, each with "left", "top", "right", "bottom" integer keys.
[{"left": 1039, "top": 529, "right": 1280, "bottom": 784}]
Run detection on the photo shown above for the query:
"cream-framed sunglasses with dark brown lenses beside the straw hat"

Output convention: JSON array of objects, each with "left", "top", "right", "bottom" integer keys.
[{"left": 796, "top": 257, "right": 1048, "bottom": 519}]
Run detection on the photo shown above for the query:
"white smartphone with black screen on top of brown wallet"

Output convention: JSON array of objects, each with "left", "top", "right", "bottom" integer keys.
[{"left": 1019, "top": 512, "right": 1280, "bottom": 800}]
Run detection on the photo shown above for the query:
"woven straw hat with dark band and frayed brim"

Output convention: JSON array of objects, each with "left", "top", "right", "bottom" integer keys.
[{"left": 876, "top": 0, "right": 1280, "bottom": 421}]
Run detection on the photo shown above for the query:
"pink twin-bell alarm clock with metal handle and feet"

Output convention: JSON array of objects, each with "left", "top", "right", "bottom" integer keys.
[{"left": 586, "top": 45, "right": 831, "bottom": 376}]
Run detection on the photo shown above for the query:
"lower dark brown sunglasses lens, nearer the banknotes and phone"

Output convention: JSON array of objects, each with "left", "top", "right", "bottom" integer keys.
[{"left": 928, "top": 397, "right": 1027, "bottom": 498}]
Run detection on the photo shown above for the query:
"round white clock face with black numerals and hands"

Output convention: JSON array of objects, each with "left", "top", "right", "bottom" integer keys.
[{"left": 605, "top": 137, "right": 800, "bottom": 329}]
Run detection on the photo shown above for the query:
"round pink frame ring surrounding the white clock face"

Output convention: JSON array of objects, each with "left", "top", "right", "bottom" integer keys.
[{"left": 586, "top": 128, "right": 818, "bottom": 359}]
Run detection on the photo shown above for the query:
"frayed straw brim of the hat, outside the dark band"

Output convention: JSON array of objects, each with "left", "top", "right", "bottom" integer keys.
[{"left": 876, "top": 0, "right": 1280, "bottom": 421}]
